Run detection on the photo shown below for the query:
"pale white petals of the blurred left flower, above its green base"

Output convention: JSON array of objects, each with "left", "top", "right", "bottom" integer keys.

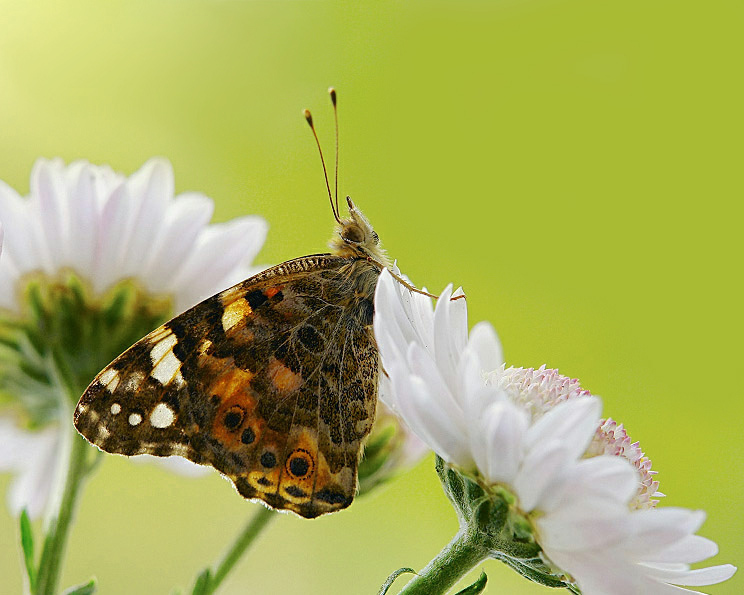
[{"left": 0, "top": 159, "right": 267, "bottom": 313}]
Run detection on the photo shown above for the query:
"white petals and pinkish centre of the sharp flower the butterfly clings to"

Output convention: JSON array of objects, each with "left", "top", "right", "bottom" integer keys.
[{"left": 374, "top": 271, "right": 735, "bottom": 595}]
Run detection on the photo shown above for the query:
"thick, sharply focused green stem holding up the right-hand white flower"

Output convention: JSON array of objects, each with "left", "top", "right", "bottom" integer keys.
[{"left": 400, "top": 528, "right": 488, "bottom": 595}]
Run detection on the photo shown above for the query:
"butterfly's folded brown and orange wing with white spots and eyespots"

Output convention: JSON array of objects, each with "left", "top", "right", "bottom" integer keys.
[{"left": 75, "top": 255, "right": 378, "bottom": 518}]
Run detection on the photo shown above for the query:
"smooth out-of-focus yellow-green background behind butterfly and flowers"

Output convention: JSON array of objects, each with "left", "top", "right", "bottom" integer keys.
[{"left": 0, "top": 0, "right": 744, "bottom": 594}]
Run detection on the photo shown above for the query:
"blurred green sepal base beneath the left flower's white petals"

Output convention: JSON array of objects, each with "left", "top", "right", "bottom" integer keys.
[{"left": 0, "top": 272, "right": 172, "bottom": 428}]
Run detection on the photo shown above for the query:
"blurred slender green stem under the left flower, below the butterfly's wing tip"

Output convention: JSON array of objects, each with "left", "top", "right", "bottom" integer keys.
[{"left": 36, "top": 428, "right": 90, "bottom": 595}]
